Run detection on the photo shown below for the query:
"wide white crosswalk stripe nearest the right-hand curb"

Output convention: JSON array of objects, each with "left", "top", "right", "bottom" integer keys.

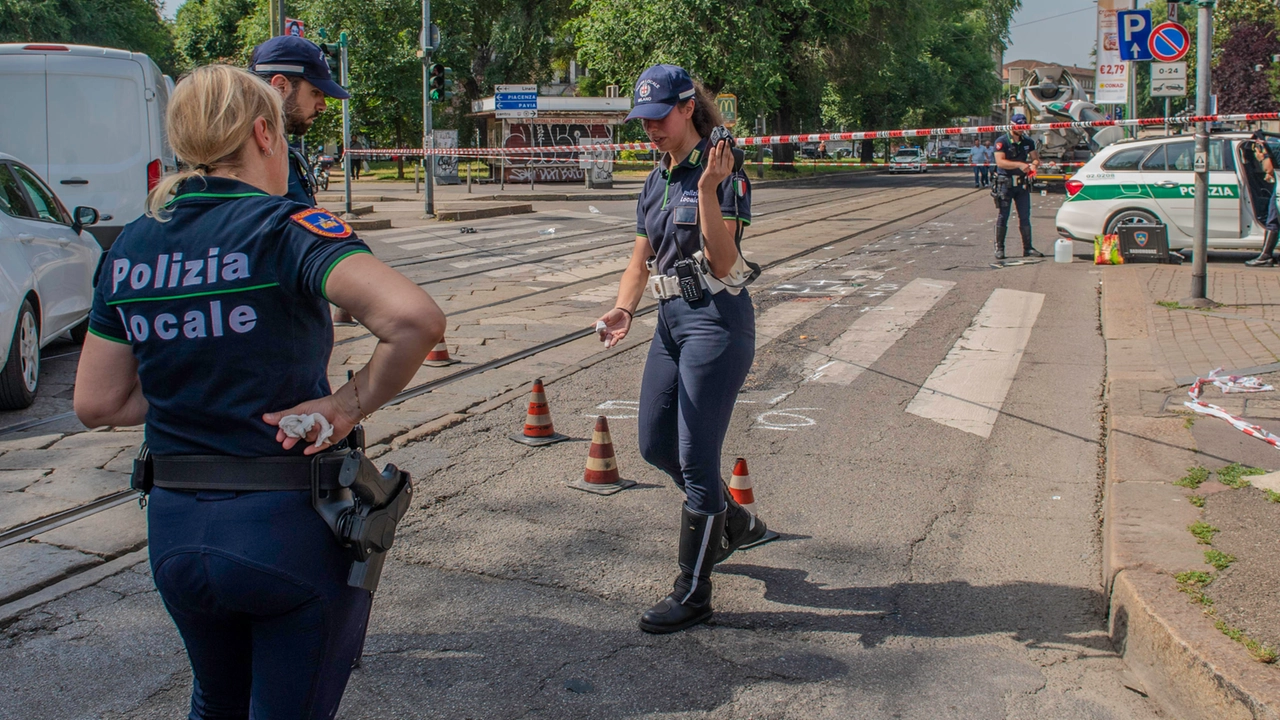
[{"left": 906, "top": 288, "right": 1044, "bottom": 438}]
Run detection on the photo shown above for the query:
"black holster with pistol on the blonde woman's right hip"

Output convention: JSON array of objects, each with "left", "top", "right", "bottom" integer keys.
[{"left": 311, "top": 447, "right": 413, "bottom": 592}]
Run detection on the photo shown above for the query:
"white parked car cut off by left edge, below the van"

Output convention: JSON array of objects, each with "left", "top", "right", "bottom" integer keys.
[{"left": 0, "top": 152, "right": 102, "bottom": 410}]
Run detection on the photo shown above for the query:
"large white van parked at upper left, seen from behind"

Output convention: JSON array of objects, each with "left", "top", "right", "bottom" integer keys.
[{"left": 0, "top": 42, "right": 178, "bottom": 247}]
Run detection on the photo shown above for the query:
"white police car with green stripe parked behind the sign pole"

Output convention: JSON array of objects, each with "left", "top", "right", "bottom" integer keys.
[{"left": 1057, "top": 132, "right": 1280, "bottom": 250}]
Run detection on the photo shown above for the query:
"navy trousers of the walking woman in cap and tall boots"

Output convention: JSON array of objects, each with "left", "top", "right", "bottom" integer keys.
[{"left": 640, "top": 290, "right": 755, "bottom": 515}]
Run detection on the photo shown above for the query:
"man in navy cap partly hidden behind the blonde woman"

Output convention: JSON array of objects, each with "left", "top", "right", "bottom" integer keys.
[{"left": 248, "top": 35, "right": 351, "bottom": 208}]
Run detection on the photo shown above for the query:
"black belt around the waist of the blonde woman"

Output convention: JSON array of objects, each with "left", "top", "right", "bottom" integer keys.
[{"left": 151, "top": 452, "right": 347, "bottom": 492}]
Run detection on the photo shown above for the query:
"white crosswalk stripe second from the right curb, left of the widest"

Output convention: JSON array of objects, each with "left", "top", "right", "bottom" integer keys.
[{"left": 805, "top": 278, "right": 956, "bottom": 386}]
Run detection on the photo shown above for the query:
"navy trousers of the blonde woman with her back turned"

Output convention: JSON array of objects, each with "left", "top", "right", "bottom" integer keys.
[{"left": 147, "top": 488, "right": 370, "bottom": 720}]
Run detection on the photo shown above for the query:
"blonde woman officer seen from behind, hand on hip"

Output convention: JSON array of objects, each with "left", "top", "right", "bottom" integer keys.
[{"left": 76, "top": 65, "right": 444, "bottom": 720}]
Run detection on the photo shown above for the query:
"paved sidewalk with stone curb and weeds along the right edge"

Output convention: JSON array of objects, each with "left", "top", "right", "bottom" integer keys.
[{"left": 1097, "top": 264, "right": 1280, "bottom": 720}]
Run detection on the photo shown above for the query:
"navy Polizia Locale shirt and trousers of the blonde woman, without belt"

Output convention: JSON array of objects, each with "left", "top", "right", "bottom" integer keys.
[{"left": 90, "top": 177, "right": 370, "bottom": 719}]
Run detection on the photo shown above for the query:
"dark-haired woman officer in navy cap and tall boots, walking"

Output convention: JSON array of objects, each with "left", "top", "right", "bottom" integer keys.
[{"left": 600, "top": 65, "right": 767, "bottom": 633}]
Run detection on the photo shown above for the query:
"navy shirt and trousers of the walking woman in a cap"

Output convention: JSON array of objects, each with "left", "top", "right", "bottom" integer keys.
[{"left": 636, "top": 140, "right": 755, "bottom": 515}]
